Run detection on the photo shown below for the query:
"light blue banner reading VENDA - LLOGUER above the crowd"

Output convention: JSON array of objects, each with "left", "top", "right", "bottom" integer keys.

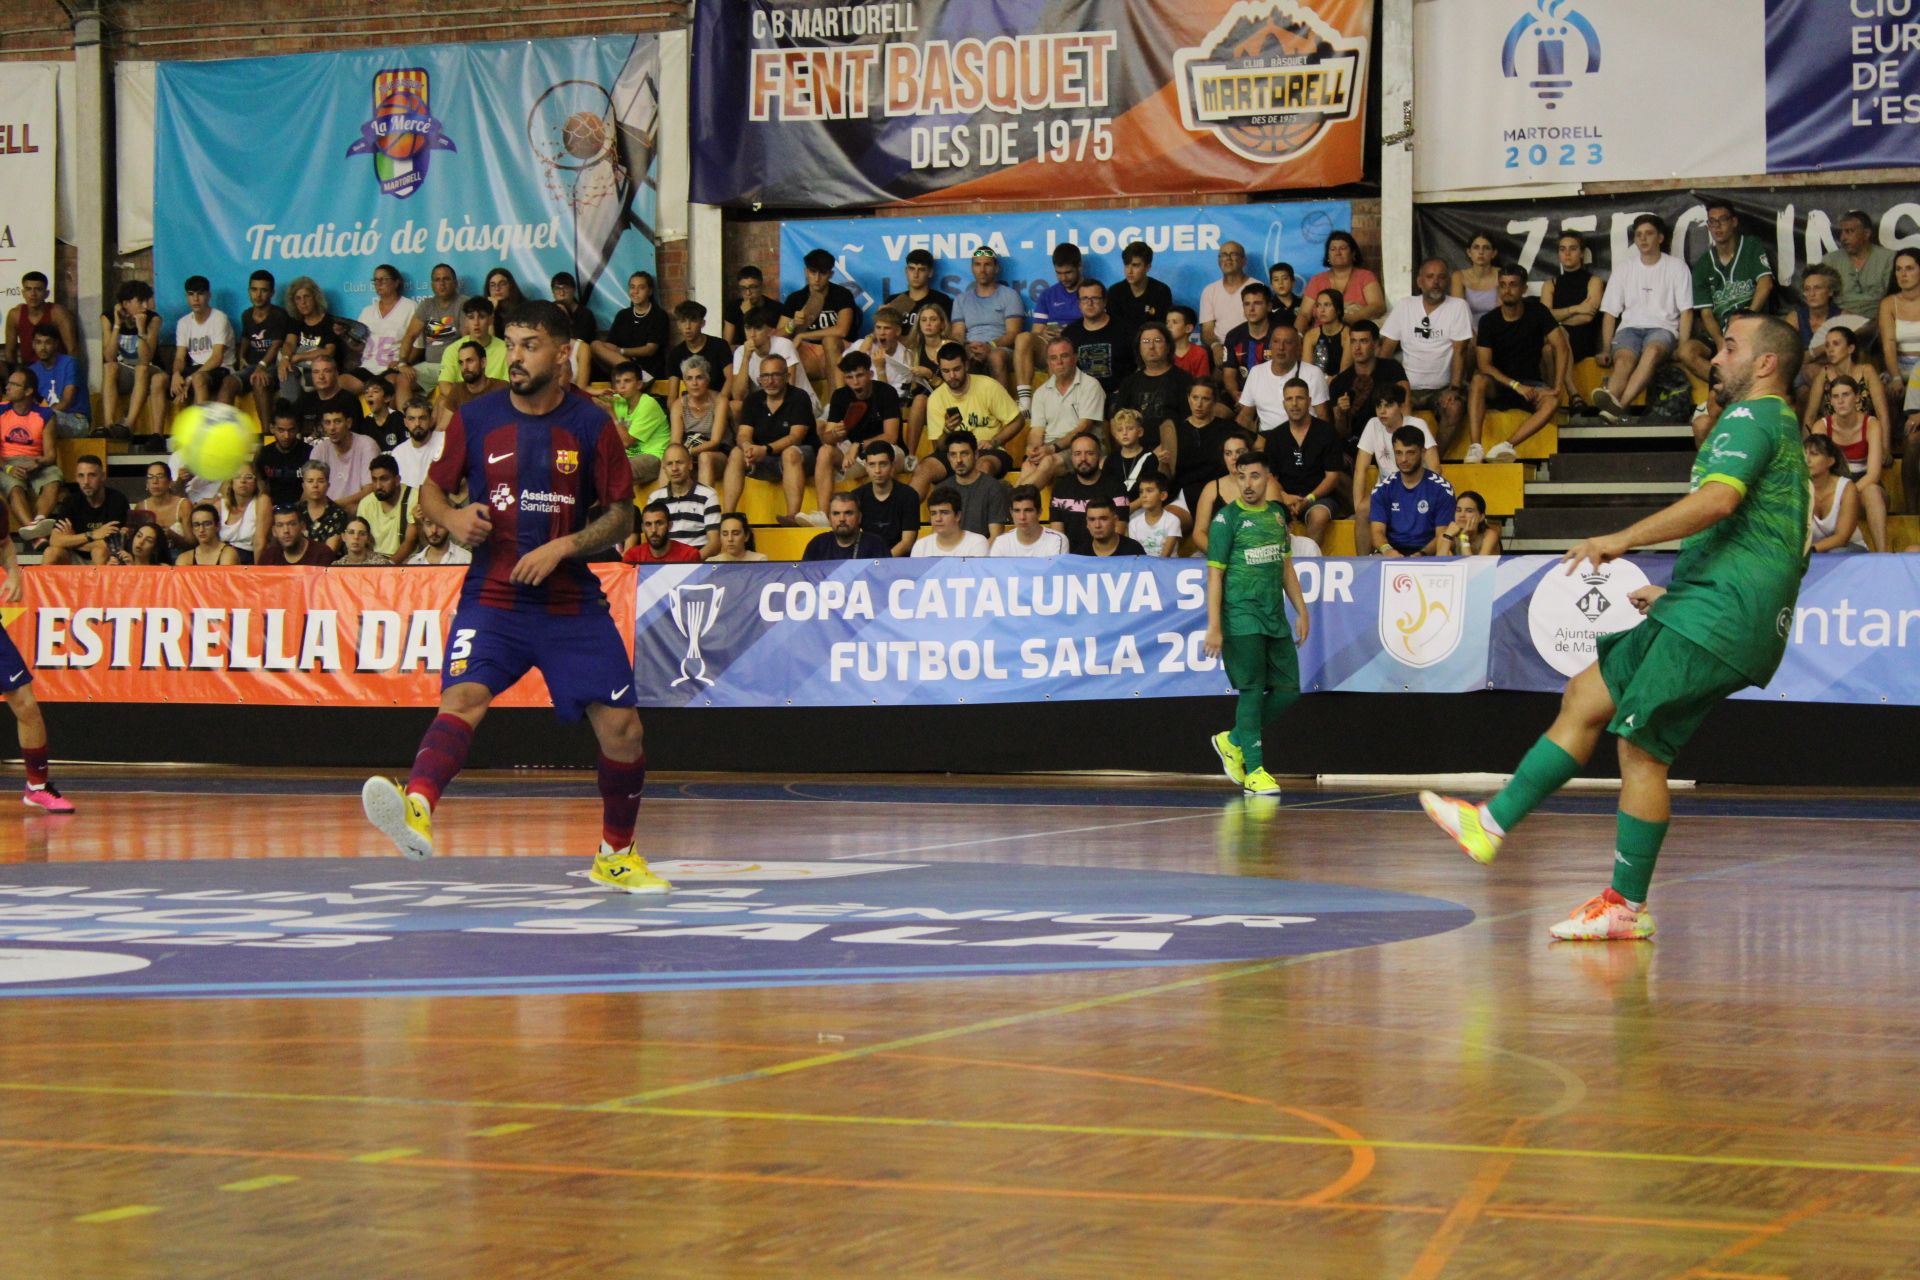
[{"left": 780, "top": 200, "right": 1354, "bottom": 335}]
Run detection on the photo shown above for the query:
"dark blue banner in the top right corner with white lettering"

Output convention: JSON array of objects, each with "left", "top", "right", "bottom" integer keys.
[{"left": 1766, "top": 0, "right": 1920, "bottom": 173}]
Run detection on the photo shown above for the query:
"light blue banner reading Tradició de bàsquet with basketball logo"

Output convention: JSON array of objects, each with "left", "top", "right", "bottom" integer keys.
[{"left": 154, "top": 35, "right": 659, "bottom": 322}]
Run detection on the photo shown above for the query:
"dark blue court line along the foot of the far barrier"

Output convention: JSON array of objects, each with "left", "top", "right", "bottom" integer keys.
[{"left": 41, "top": 775, "right": 1920, "bottom": 821}]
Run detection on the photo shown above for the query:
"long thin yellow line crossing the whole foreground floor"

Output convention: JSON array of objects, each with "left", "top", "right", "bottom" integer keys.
[{"left": 0, "top": 1084, "right": 1920, "bottom": 1176}]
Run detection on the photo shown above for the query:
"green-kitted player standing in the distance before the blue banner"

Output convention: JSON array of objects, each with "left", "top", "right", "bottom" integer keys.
[{"left": 1206, "top": 453, "right": 1308, "bottom": 796}]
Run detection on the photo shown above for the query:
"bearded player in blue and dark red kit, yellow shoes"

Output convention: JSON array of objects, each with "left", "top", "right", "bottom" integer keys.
[{"left": 361, "top": 301, "right": 670, "bottom": 892}]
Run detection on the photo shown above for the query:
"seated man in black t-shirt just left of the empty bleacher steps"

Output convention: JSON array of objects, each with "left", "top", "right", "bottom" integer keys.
[{"left": 1467, "top": 267, "right": 1572, "bottom": 462}]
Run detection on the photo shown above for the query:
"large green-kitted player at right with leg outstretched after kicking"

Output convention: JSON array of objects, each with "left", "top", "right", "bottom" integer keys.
[{"left": 1421, "top": 313, "right": 1811, "bottom": 940}]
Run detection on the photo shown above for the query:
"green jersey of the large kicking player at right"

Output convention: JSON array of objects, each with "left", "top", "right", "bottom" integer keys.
[{"left": 1649, "top": 395, "right": 1812, "bottom": 685}]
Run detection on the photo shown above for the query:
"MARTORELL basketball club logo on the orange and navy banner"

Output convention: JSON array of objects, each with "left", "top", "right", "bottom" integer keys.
[{"left": 1173, "top": 0, "right": 1367, "bottom": 165}]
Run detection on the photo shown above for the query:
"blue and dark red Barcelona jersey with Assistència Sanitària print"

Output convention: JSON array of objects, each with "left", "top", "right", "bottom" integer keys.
[{"left": 428, "top": 390, "right": 634, "bottom": 614}]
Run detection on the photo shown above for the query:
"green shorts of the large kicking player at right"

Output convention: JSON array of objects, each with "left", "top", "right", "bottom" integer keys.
[{"left": 1597, "top": 618, "right": 1753, "bottom": 764}]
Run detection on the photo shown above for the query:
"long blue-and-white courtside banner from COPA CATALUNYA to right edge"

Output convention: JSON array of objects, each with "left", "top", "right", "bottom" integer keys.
[{"left": 634, "top": 555, "right": 1920, "bottom": 706}]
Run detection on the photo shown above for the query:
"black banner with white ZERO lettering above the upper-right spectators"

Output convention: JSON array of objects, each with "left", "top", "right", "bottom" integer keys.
[{"left": 1420, "top": 182, "right": 1920, "bottom": 296}]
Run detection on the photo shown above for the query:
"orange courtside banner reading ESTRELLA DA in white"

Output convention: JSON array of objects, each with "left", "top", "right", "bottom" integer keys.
[{"left": 0, "top": 564, "right": 634, "bottom": 706}]
